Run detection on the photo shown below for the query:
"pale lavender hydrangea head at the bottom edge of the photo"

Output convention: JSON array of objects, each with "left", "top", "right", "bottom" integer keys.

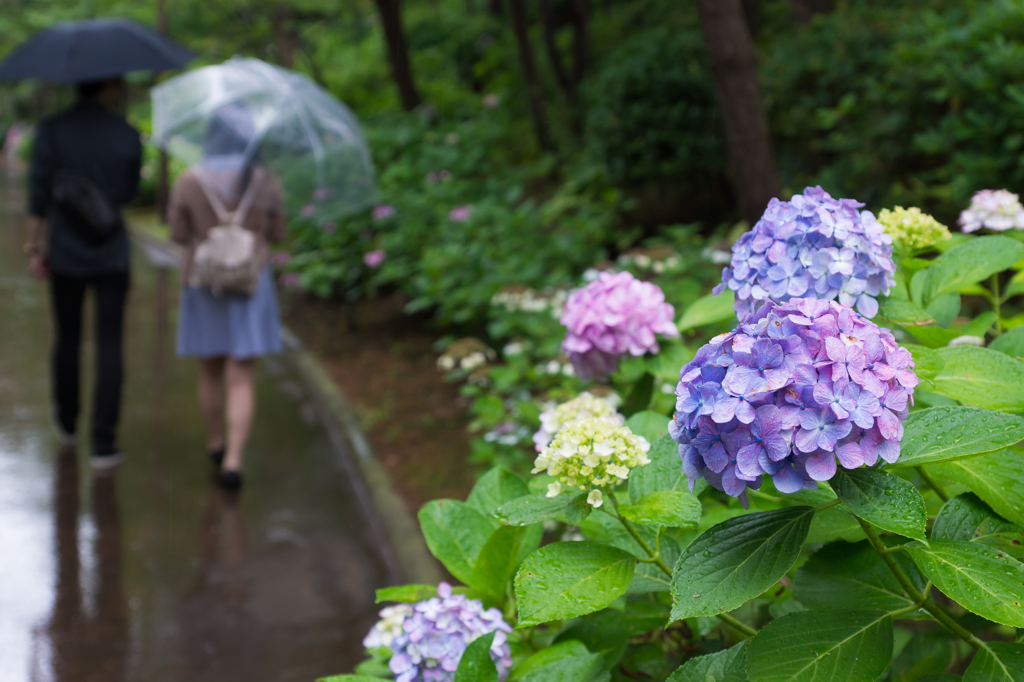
[{"left": 388, "top": 583, "right": 512, "bottom": 682}]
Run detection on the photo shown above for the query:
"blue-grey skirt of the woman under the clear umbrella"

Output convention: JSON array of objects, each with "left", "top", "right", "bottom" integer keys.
[{"left": 178, "top": 267, "right": 284, "bottom": 359}]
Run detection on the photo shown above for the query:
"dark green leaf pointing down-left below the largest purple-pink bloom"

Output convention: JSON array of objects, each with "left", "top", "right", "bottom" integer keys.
[{"left": 672, "top": 507, "right": 814, "bottom": 621}]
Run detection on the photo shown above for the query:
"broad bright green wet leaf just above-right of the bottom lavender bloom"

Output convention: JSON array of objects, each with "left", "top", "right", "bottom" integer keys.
[{"left": 515, "top": 542, "right": 636, "bottom": 628}]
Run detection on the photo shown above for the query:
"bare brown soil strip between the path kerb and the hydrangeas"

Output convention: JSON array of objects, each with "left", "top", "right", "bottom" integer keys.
[{"left": 283, "top": 295, "right": 474, "bottom": 513}]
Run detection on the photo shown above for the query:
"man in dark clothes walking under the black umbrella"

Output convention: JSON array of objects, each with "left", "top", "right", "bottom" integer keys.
[{"left": 25, "top": 78, "right": 142, "bottom": 469}]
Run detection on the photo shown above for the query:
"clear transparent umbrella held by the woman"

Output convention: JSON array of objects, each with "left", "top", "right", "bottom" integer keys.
[{"left": 153, "top": 57, "right": 377, "bottom": 218}]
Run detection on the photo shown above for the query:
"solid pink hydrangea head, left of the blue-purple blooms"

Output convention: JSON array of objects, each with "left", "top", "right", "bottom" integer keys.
[{"left": 561, "top": 272, "right": 679, "bottom": 381}]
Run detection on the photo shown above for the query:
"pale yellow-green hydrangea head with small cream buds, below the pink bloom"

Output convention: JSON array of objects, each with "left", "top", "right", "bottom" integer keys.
[{"left": 534, "top": 417, "right": 650, "bottom": 507}]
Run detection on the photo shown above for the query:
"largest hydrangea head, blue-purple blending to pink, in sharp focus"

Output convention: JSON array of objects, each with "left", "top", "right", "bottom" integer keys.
[{"left": 669, "top": 298, "right": 918, "bottom": 497}]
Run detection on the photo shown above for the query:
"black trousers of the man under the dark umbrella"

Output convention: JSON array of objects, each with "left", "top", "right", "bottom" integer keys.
[{"left": 50, "top": 272, "right": 128, "bottom": 455}]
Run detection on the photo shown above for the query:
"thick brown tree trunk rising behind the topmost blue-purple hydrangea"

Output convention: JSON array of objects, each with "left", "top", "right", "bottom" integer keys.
[{"left": 697, "top": 0, "right": 782, "bottom": 224}]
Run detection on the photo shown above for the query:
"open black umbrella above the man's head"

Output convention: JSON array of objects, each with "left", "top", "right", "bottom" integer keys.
[{"left": 0, "top": 19, "right": 193, "bottom": 83}]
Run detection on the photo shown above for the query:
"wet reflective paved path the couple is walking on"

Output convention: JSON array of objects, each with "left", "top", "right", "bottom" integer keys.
[{"left": 0, "top": 165, "right": 388, "bottom": 682}]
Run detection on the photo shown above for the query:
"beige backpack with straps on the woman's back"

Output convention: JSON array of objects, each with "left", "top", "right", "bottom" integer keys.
[{"left": 189, "top": 168, "right": 262, "bottom": 296}]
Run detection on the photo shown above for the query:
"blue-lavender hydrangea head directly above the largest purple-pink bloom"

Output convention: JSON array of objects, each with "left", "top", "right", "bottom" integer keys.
[{"left": 715, "top": 186, "right": 896, "bottom": 319}]
